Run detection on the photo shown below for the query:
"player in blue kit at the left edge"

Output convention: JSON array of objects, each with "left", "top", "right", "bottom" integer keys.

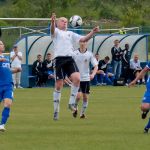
[{"left": 0, "top": 41, "right": 21, "bottom": 131}]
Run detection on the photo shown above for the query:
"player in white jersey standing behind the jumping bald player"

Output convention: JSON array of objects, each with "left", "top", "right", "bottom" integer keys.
[{"left": 73, "top": 41, "right": 98, "bottom": 118}]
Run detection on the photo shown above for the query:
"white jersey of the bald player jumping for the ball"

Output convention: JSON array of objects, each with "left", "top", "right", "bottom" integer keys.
[{"left": 52, "top": 28, "right": 82, "bottom": 58}]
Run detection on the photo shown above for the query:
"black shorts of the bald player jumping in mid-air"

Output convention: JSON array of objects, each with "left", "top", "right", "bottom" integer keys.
[{"left": 53, "top": 56, "right": 79, "bottom": 80}]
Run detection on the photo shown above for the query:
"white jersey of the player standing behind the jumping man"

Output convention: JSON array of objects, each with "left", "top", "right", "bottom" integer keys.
[{"left": 73, "top": 50, "right": 98, "bottom": 81}]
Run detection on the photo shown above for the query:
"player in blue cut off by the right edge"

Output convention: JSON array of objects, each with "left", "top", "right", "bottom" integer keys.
[{"left": 129, "top": 62, "right": 150, "bottom": 133}]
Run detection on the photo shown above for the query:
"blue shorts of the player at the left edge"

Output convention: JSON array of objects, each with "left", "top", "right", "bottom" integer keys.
[{"left": 0, "top": 84, "right": 13, "bottom": 102}]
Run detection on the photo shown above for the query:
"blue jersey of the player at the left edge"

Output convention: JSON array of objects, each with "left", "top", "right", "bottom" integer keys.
[{"left": 0, "top": 55, "right": 13, "bottom": 86}]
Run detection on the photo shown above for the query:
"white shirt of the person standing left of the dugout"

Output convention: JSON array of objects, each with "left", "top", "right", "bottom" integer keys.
[{"left": 10, "top": 51, "right": 22, "bottom": 68}]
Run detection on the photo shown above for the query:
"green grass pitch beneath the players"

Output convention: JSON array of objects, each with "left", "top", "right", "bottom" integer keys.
[{"left": 0, "top": 86, "right": 150, "bottom": 150}]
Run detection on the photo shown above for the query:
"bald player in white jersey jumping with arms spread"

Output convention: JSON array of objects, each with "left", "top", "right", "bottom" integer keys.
[{"left": 50, "top": 13, "right": 99, "bottom": 120}]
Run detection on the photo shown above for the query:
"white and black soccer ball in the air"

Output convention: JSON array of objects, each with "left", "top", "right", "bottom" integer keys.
[{"left": 69, "top": 15, "right": 82, "bottom": 28}]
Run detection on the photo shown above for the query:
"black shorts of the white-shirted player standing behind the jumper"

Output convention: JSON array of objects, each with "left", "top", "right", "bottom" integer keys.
[{"left": 79, "top": 81, "right": 90, "bottom": 94}]
